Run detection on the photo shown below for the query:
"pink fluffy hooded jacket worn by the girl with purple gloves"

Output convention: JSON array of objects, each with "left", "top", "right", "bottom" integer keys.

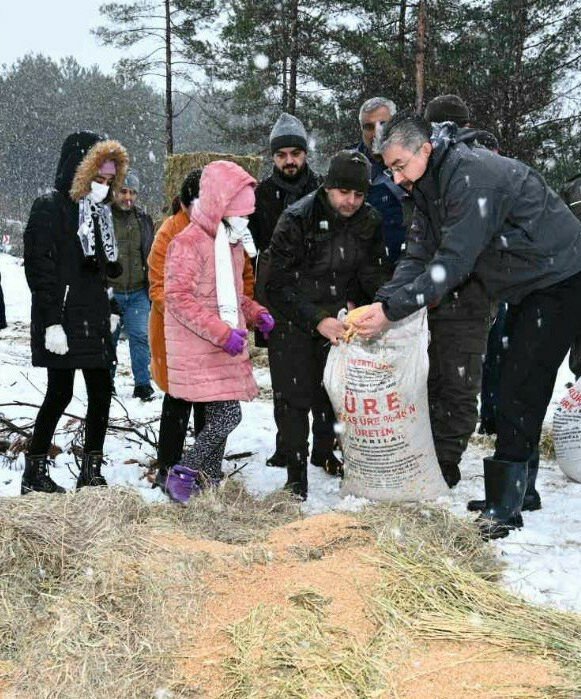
[{"left": 164, "top": 160, "right": 267, "bottom": 402}]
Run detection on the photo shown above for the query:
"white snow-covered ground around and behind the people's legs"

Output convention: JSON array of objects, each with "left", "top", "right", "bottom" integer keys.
[{"left": 0, "top": 254, "right": 581, "bottom": 612}]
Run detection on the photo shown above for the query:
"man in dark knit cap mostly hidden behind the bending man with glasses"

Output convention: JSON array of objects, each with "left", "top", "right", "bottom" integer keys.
[{"left": 424, "top": 95, "right": 491, "bottom": 488}]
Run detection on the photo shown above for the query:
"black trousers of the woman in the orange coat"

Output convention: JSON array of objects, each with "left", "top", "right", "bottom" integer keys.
[{"left": 157, "top": 393, "right": 206, "bottom": 469}]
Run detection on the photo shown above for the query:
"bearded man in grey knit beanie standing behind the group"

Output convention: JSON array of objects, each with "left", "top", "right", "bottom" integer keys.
[{"left": 248, "top": 112, "right": 324, "bottom": 469}]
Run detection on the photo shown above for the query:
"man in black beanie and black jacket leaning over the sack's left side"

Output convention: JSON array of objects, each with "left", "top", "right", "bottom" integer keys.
[{"left": 266, "top": 151, "right": 388, "bottom": 499}]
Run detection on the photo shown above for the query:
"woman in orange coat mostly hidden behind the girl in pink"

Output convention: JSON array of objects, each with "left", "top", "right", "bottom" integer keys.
[{"left": 147, "top": 169, "right": 254, "bottom": 490}]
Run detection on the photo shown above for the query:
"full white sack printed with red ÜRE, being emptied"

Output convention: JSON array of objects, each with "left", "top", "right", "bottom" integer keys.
[{"left": 324, "top": 309, "right": 448, "bottom": 501}]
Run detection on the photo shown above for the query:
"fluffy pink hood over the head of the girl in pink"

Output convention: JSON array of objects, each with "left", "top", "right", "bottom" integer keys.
[{"left": 190, "top": 160, "right": 256, "bottom": 236}]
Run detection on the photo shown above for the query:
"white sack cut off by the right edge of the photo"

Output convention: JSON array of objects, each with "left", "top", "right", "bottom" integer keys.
[{"left": 553, "top": 379, "right": 581, "bottom": 483}]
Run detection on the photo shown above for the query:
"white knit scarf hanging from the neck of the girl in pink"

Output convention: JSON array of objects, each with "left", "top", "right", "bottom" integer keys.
[{"left": 214, "top": 221, "right": 256, "bottom": 328}]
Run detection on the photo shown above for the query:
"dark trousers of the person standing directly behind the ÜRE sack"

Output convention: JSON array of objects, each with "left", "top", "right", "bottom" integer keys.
[{"left": 428, "top": 318, "right": 489, "bottom": 466}]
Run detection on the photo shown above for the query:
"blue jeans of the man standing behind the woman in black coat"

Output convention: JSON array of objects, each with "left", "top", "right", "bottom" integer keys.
[{"left": 112, "top": 289, "right": 151, "bottom": 386}]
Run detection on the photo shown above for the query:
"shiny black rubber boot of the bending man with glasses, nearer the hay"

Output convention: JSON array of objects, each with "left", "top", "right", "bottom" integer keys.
[{"left": 476, "top": 458, "right": 527, "bottom": 541}]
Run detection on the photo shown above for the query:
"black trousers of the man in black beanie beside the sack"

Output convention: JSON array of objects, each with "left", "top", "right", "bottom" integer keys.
[{"left": 268, "top": 323, "right": 335, "bottom": 468}]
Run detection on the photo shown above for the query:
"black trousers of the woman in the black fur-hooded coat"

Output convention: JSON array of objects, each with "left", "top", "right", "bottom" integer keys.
[{"left": 28, "top": 368, "right": 111, "bottom": 456}]
